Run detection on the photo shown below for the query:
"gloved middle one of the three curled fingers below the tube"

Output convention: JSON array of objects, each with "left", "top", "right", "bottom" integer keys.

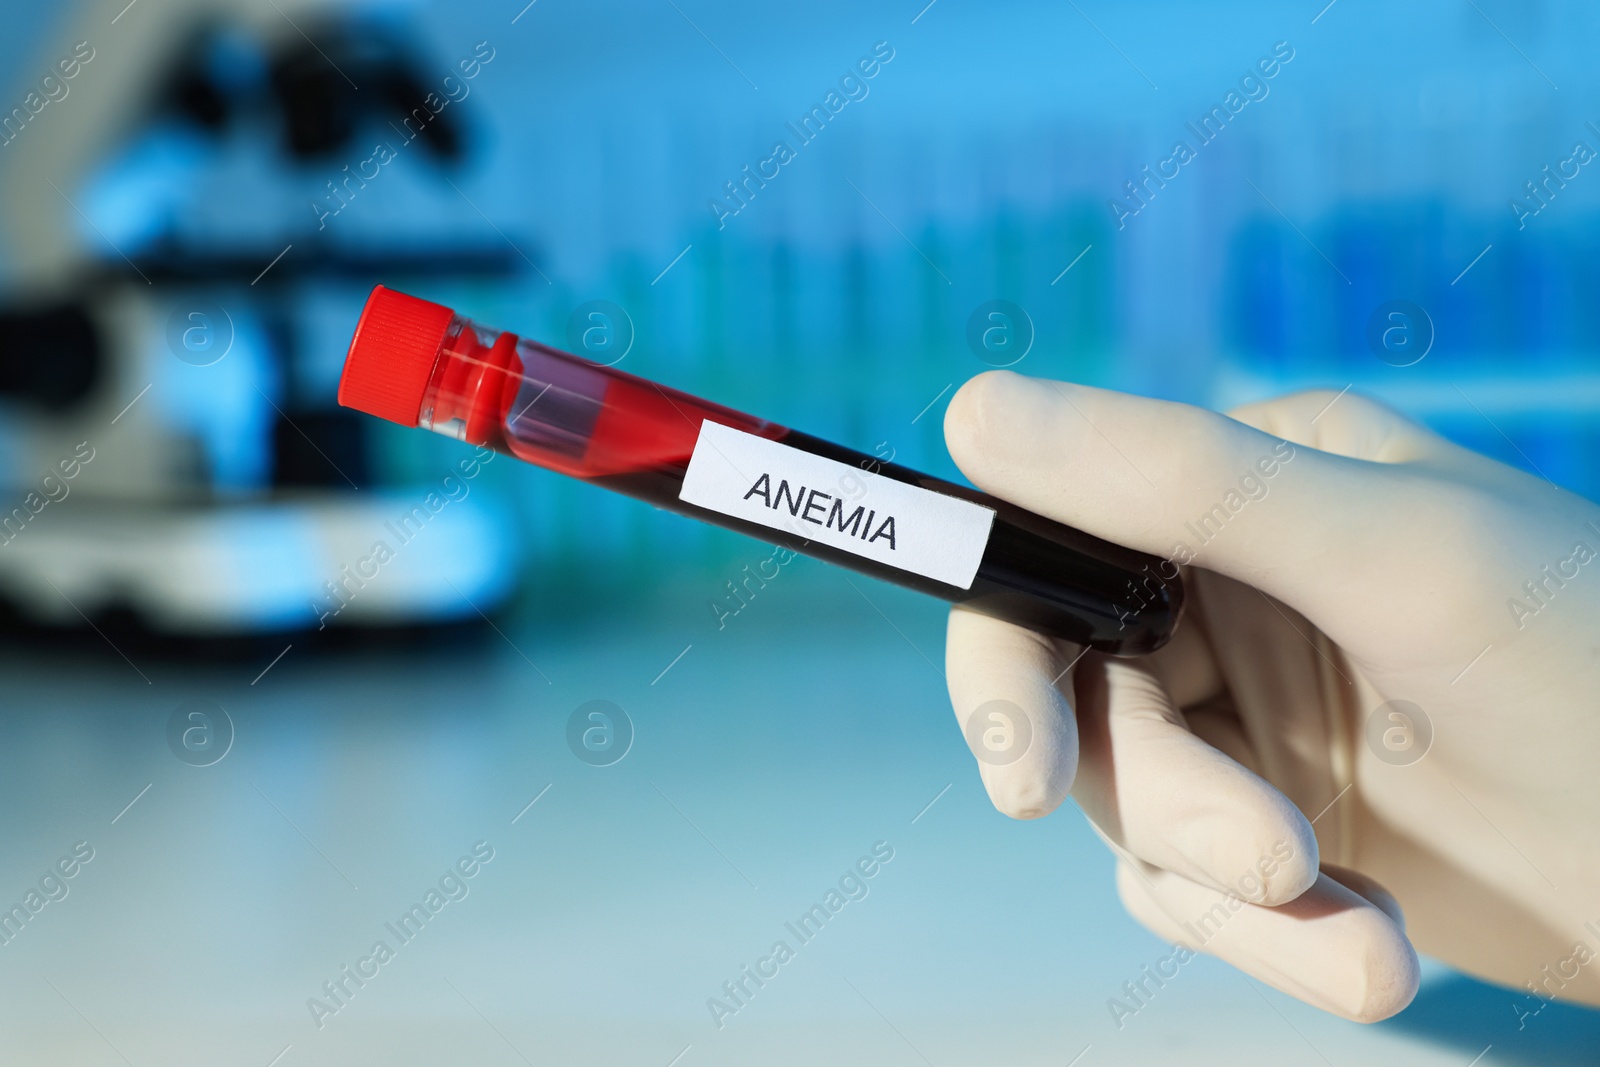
[{"left": 1072, "top": 654, "right": 1317, "bottom": 904}]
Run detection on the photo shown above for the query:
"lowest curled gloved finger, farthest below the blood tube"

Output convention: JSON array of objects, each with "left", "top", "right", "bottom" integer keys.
[{"left": 1117, "top": 862, "right": 1421, "bottom": 1022}]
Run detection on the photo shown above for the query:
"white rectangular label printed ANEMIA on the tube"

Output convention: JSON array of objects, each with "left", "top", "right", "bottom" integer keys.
[{"left": 678, "top": 422, "right": 995, "bottom": 589}]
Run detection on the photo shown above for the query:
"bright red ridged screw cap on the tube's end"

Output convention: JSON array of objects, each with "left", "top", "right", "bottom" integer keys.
[{"left": 339, "top": 285, "right": 456, "bottom": 426}]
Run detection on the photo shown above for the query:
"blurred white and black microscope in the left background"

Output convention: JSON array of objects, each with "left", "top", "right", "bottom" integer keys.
[{"left": 0, "top": 0, "right": 528, "bottom": 640}]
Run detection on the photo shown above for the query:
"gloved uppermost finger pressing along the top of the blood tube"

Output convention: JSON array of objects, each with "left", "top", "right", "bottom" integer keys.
[{"left": 944, "top": 371, "right": 1429, "bottom": 614}]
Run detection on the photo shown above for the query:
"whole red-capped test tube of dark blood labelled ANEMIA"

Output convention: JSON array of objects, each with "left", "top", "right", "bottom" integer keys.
[{"left": 339, "top": 286, "right": 1184, "bottom": 656}]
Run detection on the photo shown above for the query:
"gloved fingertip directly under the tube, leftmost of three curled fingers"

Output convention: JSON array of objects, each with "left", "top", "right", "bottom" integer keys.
[{"left": 944, "top": 608, "right": 1080, "bottom": 819}]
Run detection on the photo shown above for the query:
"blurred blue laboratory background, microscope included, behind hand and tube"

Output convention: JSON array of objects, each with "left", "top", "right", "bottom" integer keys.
[{"left": 0, "top": 0, "right": 1600, "bottom": 1067}]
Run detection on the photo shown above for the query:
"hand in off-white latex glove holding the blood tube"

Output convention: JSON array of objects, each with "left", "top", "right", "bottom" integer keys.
[{"left": 944, "top": 371, "right": 1600, "bottom": 1021}]
